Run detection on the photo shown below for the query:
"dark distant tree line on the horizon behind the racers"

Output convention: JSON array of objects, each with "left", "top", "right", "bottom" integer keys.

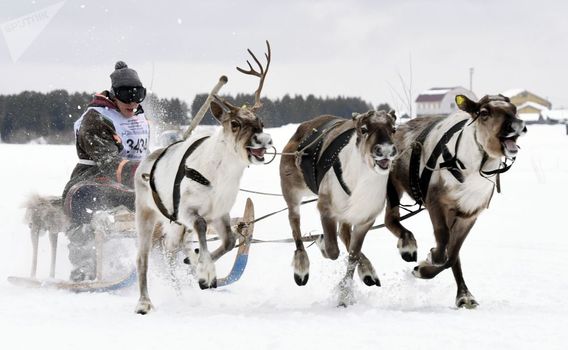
[{"left": 0, "top": 90, "right": 390, "bottom": 143}]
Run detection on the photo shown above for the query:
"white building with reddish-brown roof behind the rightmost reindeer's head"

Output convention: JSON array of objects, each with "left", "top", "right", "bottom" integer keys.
[{"left": 416, "top": 86, "right": 477, "bottom": 117}]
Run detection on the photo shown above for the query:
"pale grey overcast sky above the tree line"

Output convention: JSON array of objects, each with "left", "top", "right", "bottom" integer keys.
[{"left": 0, "top": 0, "right": 568, "bottom": 115}]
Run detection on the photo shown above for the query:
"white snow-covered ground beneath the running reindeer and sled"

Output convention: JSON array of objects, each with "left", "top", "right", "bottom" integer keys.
[{"left": 0, "top": 126, "right": 568, "bottom": 350}]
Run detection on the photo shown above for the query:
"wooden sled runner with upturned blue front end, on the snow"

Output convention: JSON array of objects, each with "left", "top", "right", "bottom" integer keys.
[{"left": 8, "top": 198, "right": 254, "bottom": 293}]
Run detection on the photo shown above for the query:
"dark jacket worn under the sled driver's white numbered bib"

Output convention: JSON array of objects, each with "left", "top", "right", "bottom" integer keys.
[{"left": 63, "top": 91, "right": 143, "bottom": 199}]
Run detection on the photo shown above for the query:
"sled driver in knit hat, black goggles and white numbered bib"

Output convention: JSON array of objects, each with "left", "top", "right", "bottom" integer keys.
[{"left": 63, "top": 61, "right": 149, "bottom": 282}]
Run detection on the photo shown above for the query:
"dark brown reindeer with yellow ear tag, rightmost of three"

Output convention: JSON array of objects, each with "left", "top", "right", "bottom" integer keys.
[{"left": 385, "top": 95, "right": 526, "bottom": 308}]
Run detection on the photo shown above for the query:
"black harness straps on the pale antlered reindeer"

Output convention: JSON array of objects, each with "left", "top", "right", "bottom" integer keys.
[{"left": 150, "top": 136, "right": 209, "bottom": 222}]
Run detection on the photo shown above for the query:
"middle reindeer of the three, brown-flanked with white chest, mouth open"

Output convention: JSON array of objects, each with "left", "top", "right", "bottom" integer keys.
[{"left": 280, "top": 111, "right": 397, "bottom": 306}]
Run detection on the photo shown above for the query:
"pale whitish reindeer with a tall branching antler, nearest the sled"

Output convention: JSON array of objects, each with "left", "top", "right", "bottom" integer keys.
[{"left": 135, "top": 41, "right": 272, "bottom": 314}]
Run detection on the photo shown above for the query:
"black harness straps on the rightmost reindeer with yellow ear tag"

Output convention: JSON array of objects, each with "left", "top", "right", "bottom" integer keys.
[{"left": 409, "top": 119, "right": 467, "bottom": 204}]
